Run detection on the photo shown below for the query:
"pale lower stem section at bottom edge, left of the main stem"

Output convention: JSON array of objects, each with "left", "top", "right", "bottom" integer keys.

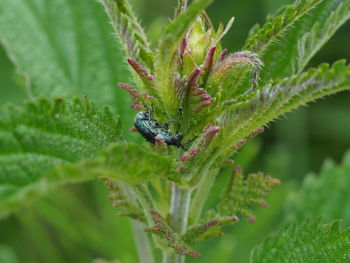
[{"left": 131, "top": 220, "right": 155, "bottom": 263}]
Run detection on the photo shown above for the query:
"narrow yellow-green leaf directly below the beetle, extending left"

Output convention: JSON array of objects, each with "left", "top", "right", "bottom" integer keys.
[{"left": 50, "top": 144, "right": 177, "bottom": 184}]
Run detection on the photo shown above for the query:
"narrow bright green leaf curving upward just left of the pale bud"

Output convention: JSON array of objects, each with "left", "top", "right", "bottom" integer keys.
[{"left": 155, "top": 0, "right": 213, "bottom": 116}]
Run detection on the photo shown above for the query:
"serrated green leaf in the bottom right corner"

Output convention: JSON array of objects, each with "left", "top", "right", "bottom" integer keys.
[{"left": 250, "top": 218, "right": 350, "bottom": 263}]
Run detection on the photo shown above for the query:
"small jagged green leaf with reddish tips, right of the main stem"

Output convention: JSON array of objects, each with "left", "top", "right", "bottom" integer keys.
[{"left": 216, "top": 168, "right": 281, "bottom": 223}]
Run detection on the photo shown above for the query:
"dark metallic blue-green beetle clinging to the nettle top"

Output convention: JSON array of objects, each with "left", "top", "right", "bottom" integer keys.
[{"left": 134, "top": 106, "right": 196, "bottom": 150}]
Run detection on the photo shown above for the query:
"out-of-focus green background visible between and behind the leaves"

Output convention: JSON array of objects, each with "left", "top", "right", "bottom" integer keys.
[{"left": 0, "top": 0, "right": 350, "bottom": 263}]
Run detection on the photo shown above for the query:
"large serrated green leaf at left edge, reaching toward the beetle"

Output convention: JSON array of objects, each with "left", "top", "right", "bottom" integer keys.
[{"left": 0, "top": 98, "right": 121, "bottom": 219}]
